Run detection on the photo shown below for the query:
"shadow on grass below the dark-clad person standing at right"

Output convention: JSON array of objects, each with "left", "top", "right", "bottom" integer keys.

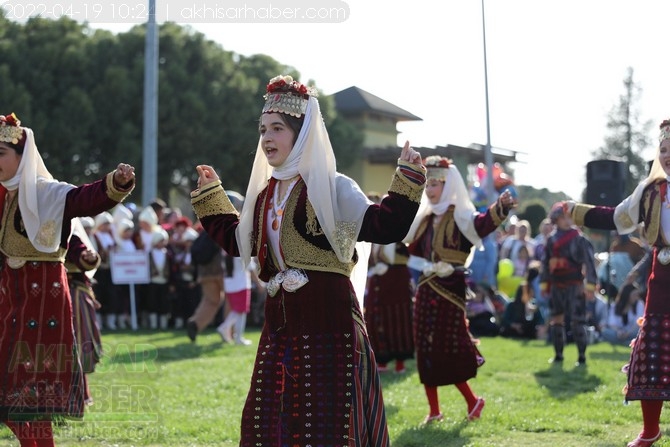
[{"left": 535, "top": 361, "right": 602, "bottom": 400}]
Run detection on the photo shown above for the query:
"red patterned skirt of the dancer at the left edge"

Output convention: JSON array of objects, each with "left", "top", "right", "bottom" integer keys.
[{"left": 0, "top": 260, "right": 84, "bottom": 420}]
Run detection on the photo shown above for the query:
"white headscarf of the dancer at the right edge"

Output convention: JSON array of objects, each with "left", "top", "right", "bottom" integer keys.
[{"left": 614, "top": 119, "right": 670, "bottom": 238}]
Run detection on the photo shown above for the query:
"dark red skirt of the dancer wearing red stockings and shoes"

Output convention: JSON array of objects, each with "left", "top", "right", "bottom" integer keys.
[{"left": 414, "top": 284, "right": 484, "bottom": 386}]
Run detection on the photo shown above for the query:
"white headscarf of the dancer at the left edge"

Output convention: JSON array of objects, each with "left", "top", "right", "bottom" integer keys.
[{"left": 2, "top": 127, "right": 75, "bottom": 253}]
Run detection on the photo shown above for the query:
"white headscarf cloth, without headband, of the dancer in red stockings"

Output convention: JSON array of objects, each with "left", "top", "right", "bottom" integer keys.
[{"left": 405, "top": 164, "right": 482, "bottom": 248}]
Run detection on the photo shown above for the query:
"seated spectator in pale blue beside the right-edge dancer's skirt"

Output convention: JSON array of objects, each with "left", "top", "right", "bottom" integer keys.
[{"left": 602, "top": 284, "right": 644, "bottom": 346}]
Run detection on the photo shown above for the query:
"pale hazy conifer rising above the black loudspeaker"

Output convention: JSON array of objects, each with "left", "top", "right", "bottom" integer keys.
[{"left": 593, "top": 67, "right": 651, "bottom": 195}]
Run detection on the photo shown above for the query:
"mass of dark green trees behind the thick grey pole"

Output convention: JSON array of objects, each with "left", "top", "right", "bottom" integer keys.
[{"left": 0, "top": 15, "right": 362, "bottom": 205}]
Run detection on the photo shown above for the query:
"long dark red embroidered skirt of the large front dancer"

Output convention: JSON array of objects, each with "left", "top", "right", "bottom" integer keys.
[{"left": 240, "top": 271, "right": 389, "bottom": 447}]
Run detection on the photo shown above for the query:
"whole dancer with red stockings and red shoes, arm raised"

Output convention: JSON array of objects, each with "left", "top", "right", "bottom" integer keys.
[{"left": 406, "top": 156, "right": 514, "bottom": 423}]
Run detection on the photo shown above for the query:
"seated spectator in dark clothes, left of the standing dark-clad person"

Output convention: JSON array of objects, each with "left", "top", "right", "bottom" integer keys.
[{"left": 500, "top": 266, "right": 545, "bottom": 339}]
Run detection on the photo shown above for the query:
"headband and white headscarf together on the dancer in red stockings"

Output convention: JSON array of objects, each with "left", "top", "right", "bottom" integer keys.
[{"left": 405, "top": 155, "right": 481, "bottom": 248}]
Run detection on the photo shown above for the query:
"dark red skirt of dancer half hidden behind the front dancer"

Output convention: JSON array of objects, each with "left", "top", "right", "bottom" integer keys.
[{"left": 365, "top": 265, "right": 414, "bottom": 363}]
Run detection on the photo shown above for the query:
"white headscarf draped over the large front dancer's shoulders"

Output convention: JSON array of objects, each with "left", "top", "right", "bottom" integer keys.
[{"left": 236, "top": 97, "right": 372, "bottom": 265}]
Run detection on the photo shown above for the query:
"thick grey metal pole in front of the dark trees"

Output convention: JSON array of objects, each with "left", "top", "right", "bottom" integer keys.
[{"left": 142, "top": 0, "right": 158, "bottom": 206}]
